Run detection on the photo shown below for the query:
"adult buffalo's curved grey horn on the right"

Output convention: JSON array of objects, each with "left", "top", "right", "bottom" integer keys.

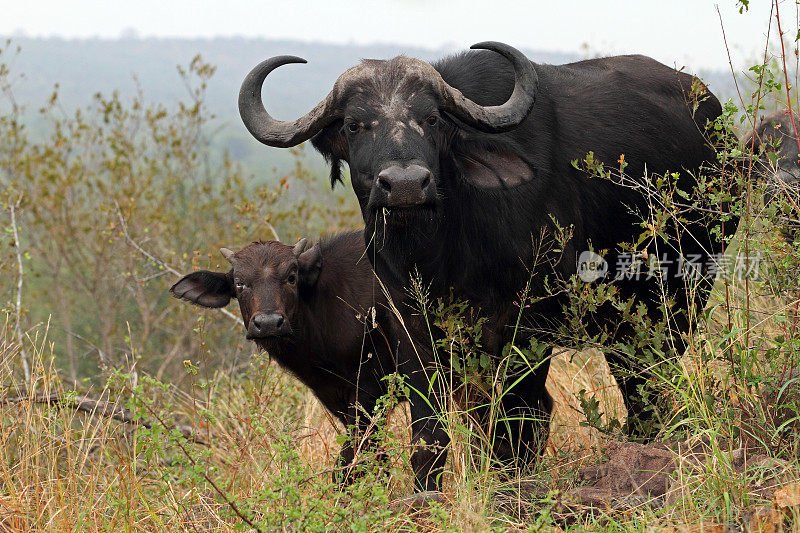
[{"left": 440, "top": 41, "right": 539, "bottom": 133}]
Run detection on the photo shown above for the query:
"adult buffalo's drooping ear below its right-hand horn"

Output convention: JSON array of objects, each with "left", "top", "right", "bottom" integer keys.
[{"left": 454, "top": 148, "right": 533, "bottom": 189}]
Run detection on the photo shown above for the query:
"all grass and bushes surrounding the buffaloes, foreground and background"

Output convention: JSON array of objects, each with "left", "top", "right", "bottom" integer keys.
[{"left": 0, "top": 3, "right": 800, "bottom": 531}]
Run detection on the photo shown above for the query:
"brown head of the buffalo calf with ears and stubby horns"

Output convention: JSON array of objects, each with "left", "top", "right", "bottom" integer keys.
[{"left": 170, "top": 239, "right": 322, "bottom": 340}]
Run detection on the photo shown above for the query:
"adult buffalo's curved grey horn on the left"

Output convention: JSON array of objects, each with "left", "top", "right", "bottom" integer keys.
[{"left": 239, "top": 56, "right": 336, "bottom": 148}]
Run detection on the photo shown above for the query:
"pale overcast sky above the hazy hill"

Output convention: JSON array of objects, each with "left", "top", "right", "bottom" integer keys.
[{"left": 0, "top": 0, "right": 797, "bottom": 69}]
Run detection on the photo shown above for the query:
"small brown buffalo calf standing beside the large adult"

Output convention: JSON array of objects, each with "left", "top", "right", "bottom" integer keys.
[{"left": 170, "top": 231, "right": 395, "bottom": 476}]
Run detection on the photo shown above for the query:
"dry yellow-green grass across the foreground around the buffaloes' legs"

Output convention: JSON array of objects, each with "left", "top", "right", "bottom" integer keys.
[{"left": 0, "top": 278, "right": 800, "bottom": 531}]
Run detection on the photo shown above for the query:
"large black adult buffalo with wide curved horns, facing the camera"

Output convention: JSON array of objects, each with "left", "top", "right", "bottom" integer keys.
[{"left": 239, "top": 42, "right": 736, "bottom": 489}]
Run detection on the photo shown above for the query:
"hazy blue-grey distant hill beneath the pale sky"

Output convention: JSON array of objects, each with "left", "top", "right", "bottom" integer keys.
[{"left": 3, "top": 37, "right": 733, "bottom": 176}]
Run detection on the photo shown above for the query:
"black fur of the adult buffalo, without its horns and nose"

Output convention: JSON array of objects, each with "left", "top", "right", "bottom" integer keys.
[{"left": 304, "top": 51, "right": 737, "bottom": 489}]
